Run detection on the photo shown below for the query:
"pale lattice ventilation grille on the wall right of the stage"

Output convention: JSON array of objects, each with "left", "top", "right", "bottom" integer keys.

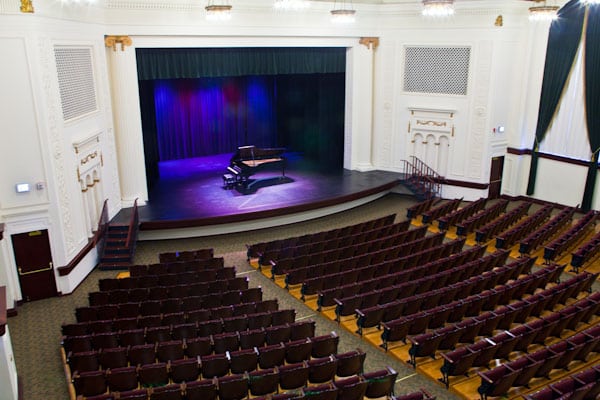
[{"left": 404, "top": 47, "right": 471, "bottom": 95}]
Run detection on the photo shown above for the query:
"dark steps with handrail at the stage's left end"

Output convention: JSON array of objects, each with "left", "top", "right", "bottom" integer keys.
[{"left": 99, "top": 200, "right": 139, "bottom": 270}]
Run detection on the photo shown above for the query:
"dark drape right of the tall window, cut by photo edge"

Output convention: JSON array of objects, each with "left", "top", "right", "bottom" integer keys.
[{"left": 581, "top": 4, "right": 600, "bottom": 212}]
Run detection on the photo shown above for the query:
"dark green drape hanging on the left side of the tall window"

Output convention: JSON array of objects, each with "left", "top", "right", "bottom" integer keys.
[{"left": 527, "top": 0, "right": 585, "bottom": 195}]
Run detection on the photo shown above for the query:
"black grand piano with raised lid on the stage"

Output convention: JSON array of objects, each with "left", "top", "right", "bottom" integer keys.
[{"left": 226, "top": 146, "right": 285, "bottom": 188}]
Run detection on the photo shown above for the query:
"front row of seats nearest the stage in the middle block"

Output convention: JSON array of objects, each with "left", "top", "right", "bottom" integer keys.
[{"left": 247, "top": 214, "right": 396, "bottom": 260}]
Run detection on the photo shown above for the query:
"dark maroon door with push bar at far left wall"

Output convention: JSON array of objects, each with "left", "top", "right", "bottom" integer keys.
[{"left": 11, "top": 229, "right": 57, "bottom": 301}]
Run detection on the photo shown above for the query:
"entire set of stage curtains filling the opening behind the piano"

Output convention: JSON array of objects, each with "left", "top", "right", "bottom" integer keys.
[{"left": 136, "top": 48, "right": 346, "bottom": 187}]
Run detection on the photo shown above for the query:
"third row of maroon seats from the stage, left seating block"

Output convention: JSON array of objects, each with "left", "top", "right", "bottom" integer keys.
[{"left": 98, "top": 267, "right": 236, "bottom": 291}]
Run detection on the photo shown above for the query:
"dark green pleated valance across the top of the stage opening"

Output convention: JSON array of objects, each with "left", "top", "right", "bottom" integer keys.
[{"left": 136, "top": 47, "right": 346, "bottom": 80}]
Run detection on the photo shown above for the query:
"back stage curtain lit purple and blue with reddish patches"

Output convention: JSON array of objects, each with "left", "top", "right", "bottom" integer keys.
[{"left": 154, "top": 76, "right": 277, "bottom": 161}]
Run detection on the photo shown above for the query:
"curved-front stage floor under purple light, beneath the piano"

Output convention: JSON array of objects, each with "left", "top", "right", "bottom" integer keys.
[{"left": 113, "top": 153, "right": 401, "bottom": 240}]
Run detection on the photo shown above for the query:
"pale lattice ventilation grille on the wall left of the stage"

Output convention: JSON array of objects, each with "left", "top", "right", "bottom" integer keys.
[{"left": 54, "top": 47, "right": 97, "bottom": 121}]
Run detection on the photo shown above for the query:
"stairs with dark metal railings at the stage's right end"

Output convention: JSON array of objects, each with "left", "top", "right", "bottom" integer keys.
[{"left": 400, "top": 156, "right": 444, "bottom": 201}]
